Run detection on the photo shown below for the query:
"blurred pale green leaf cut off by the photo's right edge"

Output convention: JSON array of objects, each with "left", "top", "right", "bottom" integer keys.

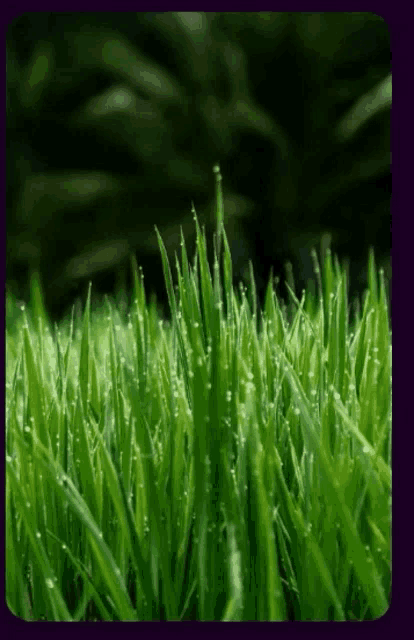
[{"left": 337, "top": 74, "right": 392, "bottom": 140}]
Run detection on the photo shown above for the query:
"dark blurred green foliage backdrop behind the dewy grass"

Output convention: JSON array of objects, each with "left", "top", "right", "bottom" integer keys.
[{"left": 6, "top": 12, "right": 391, "bottom": 320}]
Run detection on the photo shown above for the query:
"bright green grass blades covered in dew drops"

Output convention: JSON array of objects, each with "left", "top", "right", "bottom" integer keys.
[{"left": 6, "top": 165, "right": 391, "bottom": 621}]
